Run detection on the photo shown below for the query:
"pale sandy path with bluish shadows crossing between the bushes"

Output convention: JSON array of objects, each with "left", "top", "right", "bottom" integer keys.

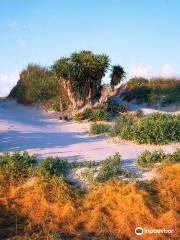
[{"left": 0, "top": 100, "right": 180, "bottom": 178}]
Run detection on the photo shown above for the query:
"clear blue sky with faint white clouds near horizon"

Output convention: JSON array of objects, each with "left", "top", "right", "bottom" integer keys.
[{"left": 0, "top": 0, "right": 180, "bottom": 96}]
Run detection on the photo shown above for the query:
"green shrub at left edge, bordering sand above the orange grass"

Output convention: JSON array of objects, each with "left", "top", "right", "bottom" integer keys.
[{"left": 0, "top": 152, "right": 36, "bottom": 184}]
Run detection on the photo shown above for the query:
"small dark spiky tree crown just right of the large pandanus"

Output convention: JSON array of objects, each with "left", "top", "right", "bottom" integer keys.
[{"left": 111, "top": 65, "right": 126, "bottom": 89}]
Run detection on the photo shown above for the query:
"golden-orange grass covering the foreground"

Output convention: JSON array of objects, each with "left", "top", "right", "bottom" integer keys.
[{"left": 0, "top": 164, "right": 180, "bottom": 240}]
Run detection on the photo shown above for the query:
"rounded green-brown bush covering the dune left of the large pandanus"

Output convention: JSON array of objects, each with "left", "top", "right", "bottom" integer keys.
[{"left": 10, "top": 64, "right": 58, "bottom": 104}]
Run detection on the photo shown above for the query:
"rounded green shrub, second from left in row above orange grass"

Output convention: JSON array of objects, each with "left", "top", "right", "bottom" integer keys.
[{"left": 37, "top": 157, "right": 69, "bottom": 177}]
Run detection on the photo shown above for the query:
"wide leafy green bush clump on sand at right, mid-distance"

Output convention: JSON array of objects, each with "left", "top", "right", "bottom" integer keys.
[{"left": 112, "top": 113, "right": 180, "bottom": 144}]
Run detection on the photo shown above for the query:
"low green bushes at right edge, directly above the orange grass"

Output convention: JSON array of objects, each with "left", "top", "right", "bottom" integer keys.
[{"left": 136, "top": 149, "right": 180, "bottom": 168}]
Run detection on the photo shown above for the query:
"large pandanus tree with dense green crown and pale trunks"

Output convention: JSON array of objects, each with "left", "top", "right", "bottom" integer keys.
[{"left": 52, "top": 51, "right": 109, "bottom": 109}]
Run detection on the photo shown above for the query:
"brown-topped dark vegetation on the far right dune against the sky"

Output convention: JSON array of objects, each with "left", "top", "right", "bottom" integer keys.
[{"left": 122, "top": 77, "right": 180, "bottom": 105}]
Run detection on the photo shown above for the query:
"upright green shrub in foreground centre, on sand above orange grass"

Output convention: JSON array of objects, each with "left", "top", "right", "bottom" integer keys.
[{"left": 97, "top": 153, "right": 121, "bottom": 182}]
